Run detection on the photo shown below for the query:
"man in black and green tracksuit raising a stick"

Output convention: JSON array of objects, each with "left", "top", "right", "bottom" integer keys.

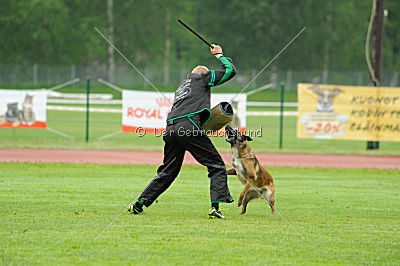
[{"left": 128, "top": 45, "right": 236, "bottom": 219}]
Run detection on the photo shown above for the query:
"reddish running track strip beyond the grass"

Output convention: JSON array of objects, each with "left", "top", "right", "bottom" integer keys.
[{"left": 0, "top": 149, "right": 400, "bottom": 169}]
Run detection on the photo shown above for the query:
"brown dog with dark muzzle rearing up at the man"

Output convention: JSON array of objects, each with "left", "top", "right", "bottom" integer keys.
[{"left": 225, "top": 125, "right": 275, "bottom": 215}]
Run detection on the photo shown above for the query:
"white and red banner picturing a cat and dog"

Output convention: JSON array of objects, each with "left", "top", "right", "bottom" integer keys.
[{"left": 0, "top": 90, "right": 47, "bottom": 128}]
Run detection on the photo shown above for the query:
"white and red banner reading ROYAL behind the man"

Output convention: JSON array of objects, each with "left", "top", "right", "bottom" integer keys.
[{"left": 122, "top": 90, "right": 247, "bottom": 134}]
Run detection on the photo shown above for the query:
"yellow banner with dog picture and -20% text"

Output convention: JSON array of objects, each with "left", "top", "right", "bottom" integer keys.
[{"left": 297, "top": 84, "right": 400, "bottom": 141}]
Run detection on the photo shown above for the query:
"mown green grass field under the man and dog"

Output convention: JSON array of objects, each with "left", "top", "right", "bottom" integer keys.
[{"left": 0, "top": 163, "right": 400, "bottom": 265}]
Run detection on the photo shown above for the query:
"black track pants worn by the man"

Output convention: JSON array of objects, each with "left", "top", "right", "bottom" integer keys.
[{"left": 138, "top": 116, "right": 233, "bottom": 207}]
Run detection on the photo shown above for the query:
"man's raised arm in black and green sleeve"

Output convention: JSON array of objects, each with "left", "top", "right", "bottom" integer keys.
[{"left": 205, "top": 44, "right": 236, "bottom": 87}]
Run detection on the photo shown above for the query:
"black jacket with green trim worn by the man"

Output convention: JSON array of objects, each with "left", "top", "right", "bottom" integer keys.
[{"left": 167, "top": 56, "right": 236, "bottom": 125}]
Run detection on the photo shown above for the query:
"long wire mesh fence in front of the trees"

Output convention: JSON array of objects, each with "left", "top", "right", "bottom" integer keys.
[{"left": 0, "top": 63, "right": 400, "bottom": 89}]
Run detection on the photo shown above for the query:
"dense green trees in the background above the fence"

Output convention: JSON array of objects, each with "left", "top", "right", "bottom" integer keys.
[{"left": 0, "top": 0, "right": 400, "bottom": 78}]
